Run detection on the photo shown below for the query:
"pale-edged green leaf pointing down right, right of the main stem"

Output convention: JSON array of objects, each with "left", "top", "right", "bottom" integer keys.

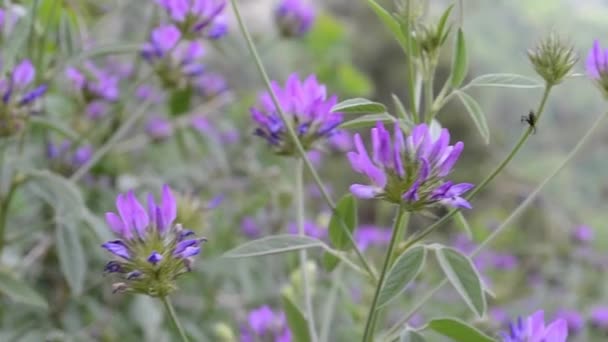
[{"left": 435, "top": 246, "right": 487, "bottom": 317}]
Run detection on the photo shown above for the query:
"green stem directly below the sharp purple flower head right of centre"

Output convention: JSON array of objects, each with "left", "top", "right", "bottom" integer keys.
[{"left": 363, "top": 207, "right": 408, "bottom": 342}]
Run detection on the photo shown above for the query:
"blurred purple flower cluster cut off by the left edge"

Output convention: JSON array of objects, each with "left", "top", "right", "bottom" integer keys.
[{"left": 0, "top": 59, "right": 47, "bottom": 137}]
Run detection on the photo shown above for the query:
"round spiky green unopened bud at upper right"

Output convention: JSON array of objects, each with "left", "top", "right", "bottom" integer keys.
[{"left": 528, "top": 33, "right": 578, "bottom": 85}]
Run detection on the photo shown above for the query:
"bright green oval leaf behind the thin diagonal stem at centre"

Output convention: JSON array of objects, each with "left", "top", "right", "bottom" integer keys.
[{"left": 329, "top": 194, "right": 357, "bottom": 250}]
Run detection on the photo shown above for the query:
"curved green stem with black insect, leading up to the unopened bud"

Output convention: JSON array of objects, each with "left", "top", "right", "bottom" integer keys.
[{"left": 404, "top": 84, "right": 553, "bottom": 249}]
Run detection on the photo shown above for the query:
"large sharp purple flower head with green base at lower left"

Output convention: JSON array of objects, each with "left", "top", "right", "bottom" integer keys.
[{"left": 102, "top": 185, "right": 206, "bottom": 297}]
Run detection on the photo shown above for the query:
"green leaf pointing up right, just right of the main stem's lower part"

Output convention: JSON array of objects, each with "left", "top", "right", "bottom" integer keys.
[{"left": 377, "top": 246, "right": 426, "bottom": 309}]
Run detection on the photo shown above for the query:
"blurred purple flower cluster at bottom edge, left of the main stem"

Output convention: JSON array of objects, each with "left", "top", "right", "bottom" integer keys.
[{"left": 241, "top": 305, "right": 292, "bottom": 342}]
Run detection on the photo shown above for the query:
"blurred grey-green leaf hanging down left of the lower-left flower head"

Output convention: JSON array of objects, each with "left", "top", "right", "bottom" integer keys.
[{"left": 55, "top": 221, "right": 87, "bottom": 296}]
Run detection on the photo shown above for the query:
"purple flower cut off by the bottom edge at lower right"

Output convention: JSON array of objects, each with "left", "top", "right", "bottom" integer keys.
[{"left": 501, "top": 310, "right": 568, "bottom": 342}]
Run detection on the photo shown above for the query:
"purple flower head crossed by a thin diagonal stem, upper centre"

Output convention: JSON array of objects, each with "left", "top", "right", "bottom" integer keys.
[{"left": 251, "top": 74, "right": 342, "bottom": 155}]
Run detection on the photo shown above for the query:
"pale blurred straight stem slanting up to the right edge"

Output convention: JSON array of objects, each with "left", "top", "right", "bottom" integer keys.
[{"left": 386, "top": 112, "right": 608, "bottom": 340}]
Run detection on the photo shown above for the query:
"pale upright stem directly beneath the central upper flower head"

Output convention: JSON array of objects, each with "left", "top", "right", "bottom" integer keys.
[{"left": 295, "top": 159, "right": 318, "bottom": 342}]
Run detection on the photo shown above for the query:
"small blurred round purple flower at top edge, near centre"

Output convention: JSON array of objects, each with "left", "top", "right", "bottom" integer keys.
[{"left": 275, "top": 0, "right": 315, "bottom": 37}]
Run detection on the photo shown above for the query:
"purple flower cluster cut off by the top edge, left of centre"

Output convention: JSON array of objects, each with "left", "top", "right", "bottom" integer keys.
[{"left": 156, "top": 0, "right": 228, "bottom": 39}]
